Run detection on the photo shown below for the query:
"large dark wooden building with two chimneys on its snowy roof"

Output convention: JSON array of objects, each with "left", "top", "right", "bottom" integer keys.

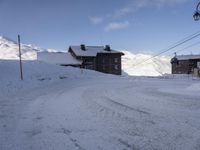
[{"left": 68, "top": 45, "right": 124, "bottom": 75}]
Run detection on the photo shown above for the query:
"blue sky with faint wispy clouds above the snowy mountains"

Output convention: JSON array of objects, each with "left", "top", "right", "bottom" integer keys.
[{"left": 0, "top": 0, "right": 200, "bottom": 53}]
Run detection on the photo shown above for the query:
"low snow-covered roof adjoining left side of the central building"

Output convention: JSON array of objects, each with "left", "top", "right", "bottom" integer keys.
[{"left": 37, "top": 52, "right": 82, "bottom": 65}]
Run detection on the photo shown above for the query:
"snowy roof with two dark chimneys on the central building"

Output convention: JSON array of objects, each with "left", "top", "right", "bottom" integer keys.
[{"left": 70, "top": 46, "right": 122, "bottom": 57}]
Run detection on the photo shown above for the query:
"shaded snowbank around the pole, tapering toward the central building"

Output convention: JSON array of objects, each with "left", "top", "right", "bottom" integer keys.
[{"left": 0, "top": 60, "right": 109, "bottom": 99}]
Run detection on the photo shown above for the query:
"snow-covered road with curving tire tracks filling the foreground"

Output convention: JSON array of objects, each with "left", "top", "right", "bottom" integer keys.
[{"left": 0, "top": 76, "right": 200, "bottom": 150}]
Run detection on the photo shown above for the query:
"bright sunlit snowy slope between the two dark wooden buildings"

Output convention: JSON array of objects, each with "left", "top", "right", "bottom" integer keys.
[{"left": 122, "top": 51, "right": 171, "bottom": 76}]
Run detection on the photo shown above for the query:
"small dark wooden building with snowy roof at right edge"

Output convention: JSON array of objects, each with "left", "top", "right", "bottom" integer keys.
[{"left": 171, "top": 55, "right": 200, "bottom": 74}]
